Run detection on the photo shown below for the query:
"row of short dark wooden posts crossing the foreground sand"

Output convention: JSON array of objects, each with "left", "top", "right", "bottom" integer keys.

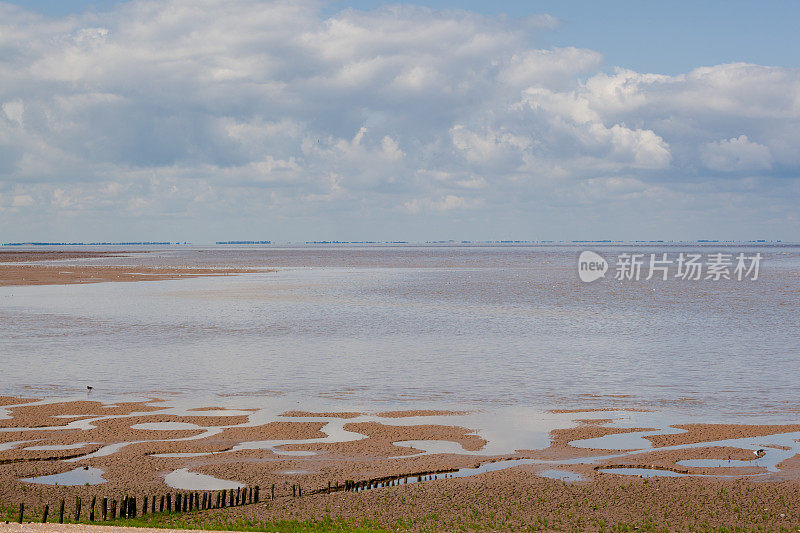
[{"left": 12, "top": 474, "right": 454, "bottom": 524}]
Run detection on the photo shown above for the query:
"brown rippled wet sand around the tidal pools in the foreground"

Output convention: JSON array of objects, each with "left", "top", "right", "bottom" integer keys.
[{"left": 0, "top": 401, "right": 800, "bottom": 531}]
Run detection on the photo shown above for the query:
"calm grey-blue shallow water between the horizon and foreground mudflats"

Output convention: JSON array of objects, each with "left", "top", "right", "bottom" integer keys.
[{"left": 0, "top": 246, "right": 800, "bottom": 417}]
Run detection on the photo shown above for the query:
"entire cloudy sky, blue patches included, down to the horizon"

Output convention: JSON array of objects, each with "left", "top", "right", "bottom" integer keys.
[{"left": 0, "top": 0, "right": 800, "bottom": 242}]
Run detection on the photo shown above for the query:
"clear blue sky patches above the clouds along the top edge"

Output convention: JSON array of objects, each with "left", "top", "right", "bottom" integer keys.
[{"left": 12, "top": 0, "right": 800, "bottom": 74}]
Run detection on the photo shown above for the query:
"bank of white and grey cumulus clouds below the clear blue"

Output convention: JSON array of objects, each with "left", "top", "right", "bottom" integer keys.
[{"left": 0, "top": 0, "right": 800, "bottom": 240}]
